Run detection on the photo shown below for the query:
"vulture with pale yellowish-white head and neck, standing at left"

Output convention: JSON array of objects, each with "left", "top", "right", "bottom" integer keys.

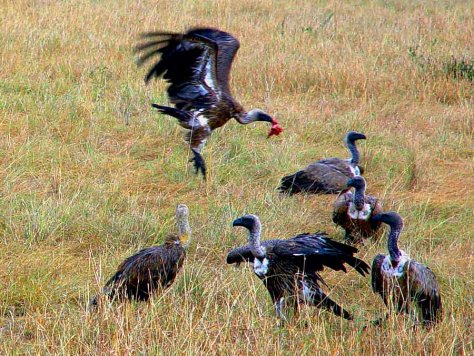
[{"left": 89, "top": 204, "right": 191, "bottom": 307}]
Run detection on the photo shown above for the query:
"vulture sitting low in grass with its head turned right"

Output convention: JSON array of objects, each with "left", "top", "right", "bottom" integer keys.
[{"left": 278, "top": 131, "right": 366, "bottom": 195}]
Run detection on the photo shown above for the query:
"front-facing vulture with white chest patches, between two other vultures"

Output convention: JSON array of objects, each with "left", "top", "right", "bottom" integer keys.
[{"left": 332, "top": 176, "right": 382, "bottom": 243}]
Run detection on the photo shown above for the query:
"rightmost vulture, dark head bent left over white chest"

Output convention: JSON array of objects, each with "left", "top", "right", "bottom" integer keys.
[{"left": 372, "top": 211, "right": 442, "bottom": 327}]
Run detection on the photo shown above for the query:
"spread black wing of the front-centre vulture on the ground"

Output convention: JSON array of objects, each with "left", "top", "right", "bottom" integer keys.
[{"left": 272, "top": 232, "right": 370, "bottom": 276}]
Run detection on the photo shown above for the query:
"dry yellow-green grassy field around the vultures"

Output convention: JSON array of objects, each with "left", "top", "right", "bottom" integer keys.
[{"left": 0, "top": 0, "right": 474, "bottom": 355}]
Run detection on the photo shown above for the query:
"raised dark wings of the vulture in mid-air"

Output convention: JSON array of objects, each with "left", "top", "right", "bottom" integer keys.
[{"left": 136, "top": 28, "right": 239, "bottom": 109}]
